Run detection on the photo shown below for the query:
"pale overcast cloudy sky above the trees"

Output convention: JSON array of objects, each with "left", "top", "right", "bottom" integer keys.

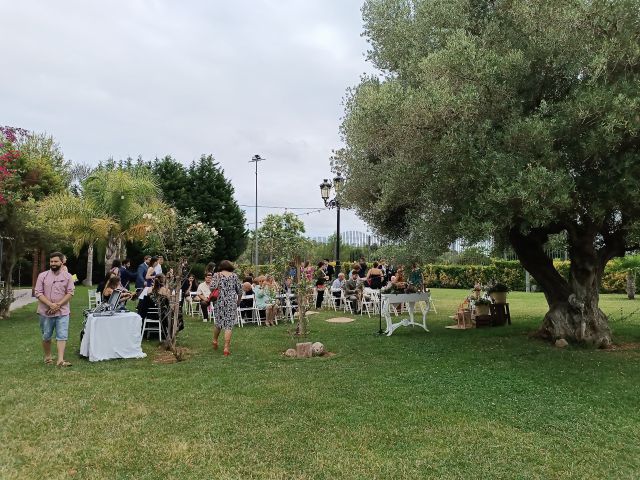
[{"left": 0, "top": 0, "right": 372, "bottom": 236}]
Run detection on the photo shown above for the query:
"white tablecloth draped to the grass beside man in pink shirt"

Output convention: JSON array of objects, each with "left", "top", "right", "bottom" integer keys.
[{"left": 80, "top": 312, "right": 147, "bottom": 362}]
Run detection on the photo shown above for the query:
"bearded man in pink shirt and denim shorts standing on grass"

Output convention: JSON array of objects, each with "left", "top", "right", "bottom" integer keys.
[{"left": 35, "top": 252, "right": 74, "bottom": 367}]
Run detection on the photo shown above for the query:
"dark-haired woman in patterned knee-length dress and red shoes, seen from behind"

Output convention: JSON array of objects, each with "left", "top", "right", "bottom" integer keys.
[{"left": 213, "top": 260, "right": 242, "bottom": 357}]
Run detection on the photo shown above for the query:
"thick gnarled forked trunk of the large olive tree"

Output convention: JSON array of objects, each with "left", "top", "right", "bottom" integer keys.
[{"left": 509, "top": 225, "right": 611, "bottom": 348}]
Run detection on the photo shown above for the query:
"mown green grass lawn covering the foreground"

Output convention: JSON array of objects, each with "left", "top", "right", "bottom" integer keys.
[{"left": 0, "top": 288, "right": 640, "bottom": 479}]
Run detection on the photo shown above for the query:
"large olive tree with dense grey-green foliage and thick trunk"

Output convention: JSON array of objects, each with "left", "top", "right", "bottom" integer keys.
[{"left": 335, "top": 0, "right": 640, "bottom": 346}]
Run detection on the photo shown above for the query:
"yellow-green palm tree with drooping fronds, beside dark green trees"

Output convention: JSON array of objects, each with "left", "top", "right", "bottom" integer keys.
[{"left": 41, "top": 168, "right": 169, "bottom": 284}]
